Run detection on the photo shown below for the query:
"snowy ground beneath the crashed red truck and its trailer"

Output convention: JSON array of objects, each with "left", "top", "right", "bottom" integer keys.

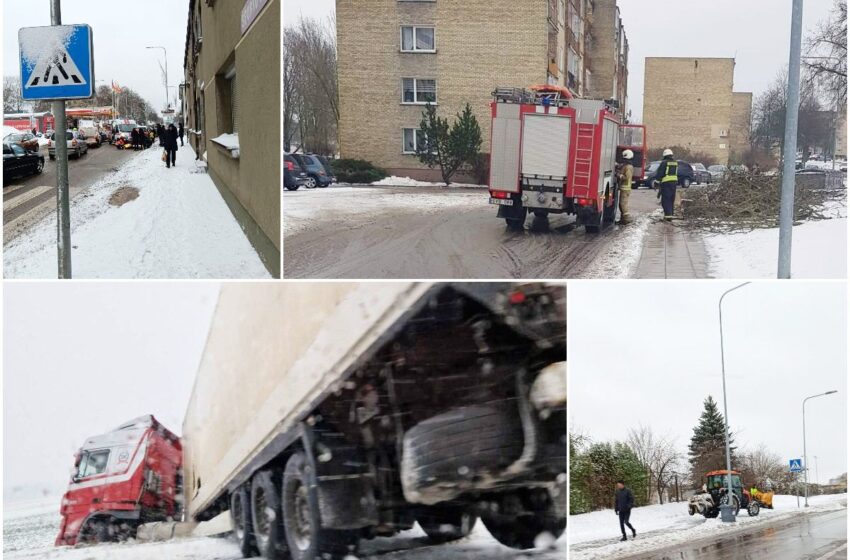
[{"left": 3, "top": 504, "right": 567, "bottom": 560}]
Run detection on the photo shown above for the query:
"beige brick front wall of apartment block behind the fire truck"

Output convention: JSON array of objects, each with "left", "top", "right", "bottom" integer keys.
[{"left": 336, "top": 0, "right": 548, "bottom": 179}]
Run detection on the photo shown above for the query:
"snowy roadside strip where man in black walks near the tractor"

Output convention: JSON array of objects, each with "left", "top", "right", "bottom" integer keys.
[{"left": 567, "top": 494, "right": 847, "bottom": 560}]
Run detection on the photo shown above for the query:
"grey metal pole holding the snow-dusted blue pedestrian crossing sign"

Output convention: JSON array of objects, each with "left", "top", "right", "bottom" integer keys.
[{"left": 50, "top": 0, "right": 71, "bottom": 278}]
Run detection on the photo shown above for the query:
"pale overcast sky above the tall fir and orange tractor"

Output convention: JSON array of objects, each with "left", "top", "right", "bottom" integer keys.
[{"left": 568, "top": 281, "right": 847, "bottom": 482}]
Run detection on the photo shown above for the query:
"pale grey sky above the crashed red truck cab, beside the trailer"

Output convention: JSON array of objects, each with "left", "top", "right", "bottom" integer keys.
[{"left": 3, "top": 282, "right": 218, "bottom": 503}]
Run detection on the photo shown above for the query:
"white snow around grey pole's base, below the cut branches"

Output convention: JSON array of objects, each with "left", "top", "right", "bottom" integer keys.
[{"left": 705, "top": 205, "right": 847, "bottom": 278}]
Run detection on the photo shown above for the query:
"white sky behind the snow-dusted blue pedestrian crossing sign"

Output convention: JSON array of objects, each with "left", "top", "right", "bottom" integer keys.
[{"left": 3, "top": 0, "right": 189, "bottom": 110}]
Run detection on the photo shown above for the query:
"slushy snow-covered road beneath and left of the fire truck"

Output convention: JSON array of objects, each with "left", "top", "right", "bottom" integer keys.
[{"left": 283, "top": 186, "right": 655, "bottom": 278}]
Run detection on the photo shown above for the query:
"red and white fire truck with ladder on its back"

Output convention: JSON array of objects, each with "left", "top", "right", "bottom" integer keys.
[{"left": 489, "top": 86, "right": 645, "bottom": 232}]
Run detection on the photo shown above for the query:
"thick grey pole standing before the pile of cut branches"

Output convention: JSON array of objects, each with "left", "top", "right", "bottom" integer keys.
[{"left": 776, "top": 0, "right": 803, "bottom": 279}]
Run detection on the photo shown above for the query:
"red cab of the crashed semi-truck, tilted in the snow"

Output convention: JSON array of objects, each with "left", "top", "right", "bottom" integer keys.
[{"left": 56, "top": 415, "right": 183, "bottom": 546}]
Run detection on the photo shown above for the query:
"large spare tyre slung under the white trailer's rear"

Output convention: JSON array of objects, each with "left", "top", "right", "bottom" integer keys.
[{"left": 401, "top": 401, "right": 525, "bottom": 503}]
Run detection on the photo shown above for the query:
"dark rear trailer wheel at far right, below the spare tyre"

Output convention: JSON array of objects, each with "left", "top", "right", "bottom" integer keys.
[{"left": 481, "top": 488, "right": 567, "bottom": 550}]
